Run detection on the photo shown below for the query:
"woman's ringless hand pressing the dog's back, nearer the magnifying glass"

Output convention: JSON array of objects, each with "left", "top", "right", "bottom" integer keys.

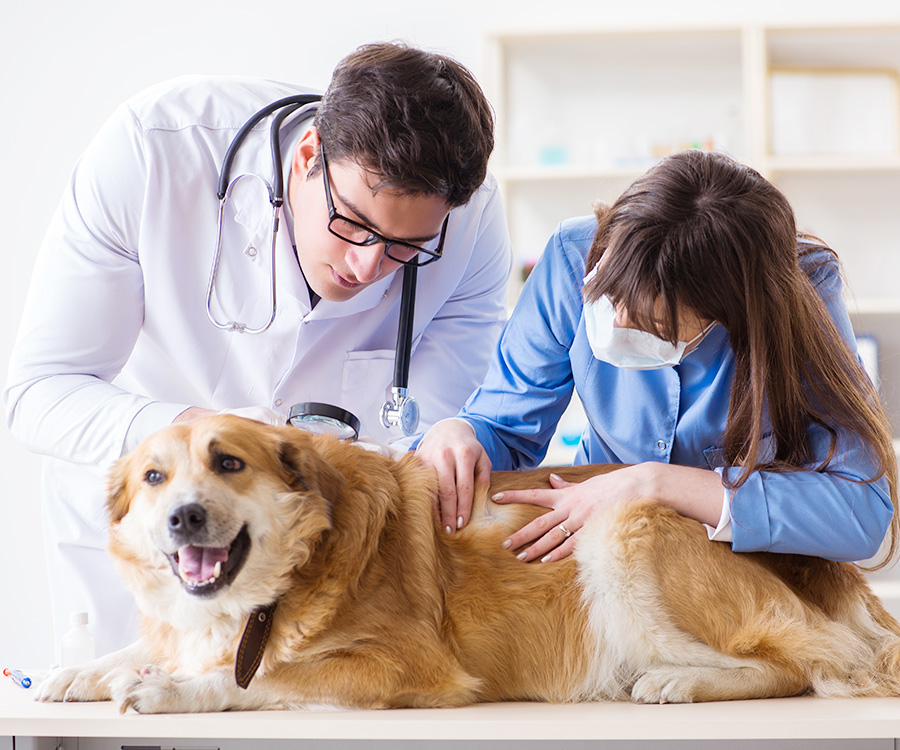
[{"left": 416, "top": 419, "right": 491, "bottom": 534}]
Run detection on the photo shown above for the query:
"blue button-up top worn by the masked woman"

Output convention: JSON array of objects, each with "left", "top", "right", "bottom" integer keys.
[{"left": 460, "top": 216, "right": 893, "bottom": 560}]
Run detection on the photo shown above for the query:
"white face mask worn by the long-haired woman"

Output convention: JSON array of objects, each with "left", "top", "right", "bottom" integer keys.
[{"left": 584, "top": 296, "right": 715, "bottom": 370}]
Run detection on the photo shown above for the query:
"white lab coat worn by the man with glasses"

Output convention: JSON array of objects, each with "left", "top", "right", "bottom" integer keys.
[{"left": 3, "top": 77, "right": 511, "bottom": 653}]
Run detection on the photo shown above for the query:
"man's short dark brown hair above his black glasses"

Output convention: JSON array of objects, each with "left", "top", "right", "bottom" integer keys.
[{"left": 310, "top": 43, "right": 494, "bottom": 206}]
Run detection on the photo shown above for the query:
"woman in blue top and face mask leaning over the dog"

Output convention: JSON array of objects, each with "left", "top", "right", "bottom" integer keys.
[{"left": 417, "top": 151, "right": 898, "bottom": 562}]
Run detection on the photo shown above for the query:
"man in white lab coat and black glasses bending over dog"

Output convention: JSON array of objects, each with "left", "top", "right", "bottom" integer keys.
[{"left": 4, "top": 44, "right": 511, "bottom": 655}]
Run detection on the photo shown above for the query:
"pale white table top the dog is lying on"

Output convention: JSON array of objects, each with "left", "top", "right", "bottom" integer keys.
[{"left": 0, "top": 679, "right": 900, "bottom": 741}]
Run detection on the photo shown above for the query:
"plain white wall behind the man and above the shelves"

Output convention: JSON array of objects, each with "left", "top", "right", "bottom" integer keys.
[{"left": 0, "top": 0, "right": 900, "bottom": 667}]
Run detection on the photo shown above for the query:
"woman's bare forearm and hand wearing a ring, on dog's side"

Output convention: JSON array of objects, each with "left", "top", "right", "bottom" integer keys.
[{"left": 492, "top": 462, "right": 723, "bottom": 562}]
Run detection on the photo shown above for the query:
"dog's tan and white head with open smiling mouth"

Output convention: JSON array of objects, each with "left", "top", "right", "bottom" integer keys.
[{"left": 107, "top": 416, "right": 344, "bottom": 624}]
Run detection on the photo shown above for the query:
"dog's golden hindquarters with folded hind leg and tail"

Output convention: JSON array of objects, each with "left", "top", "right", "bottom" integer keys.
[{"left": 576, "top": 503, "right": 900, "bottom": 702}]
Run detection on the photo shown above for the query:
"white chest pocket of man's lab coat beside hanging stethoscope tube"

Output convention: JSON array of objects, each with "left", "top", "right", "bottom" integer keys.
[{"left": 341, "top": 349, "right": 396, "bottom": 442}]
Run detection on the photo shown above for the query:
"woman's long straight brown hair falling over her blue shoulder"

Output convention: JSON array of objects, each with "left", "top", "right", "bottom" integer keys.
[{"left": 584, "top": 151, "right": 900, "bottom": 567}]
